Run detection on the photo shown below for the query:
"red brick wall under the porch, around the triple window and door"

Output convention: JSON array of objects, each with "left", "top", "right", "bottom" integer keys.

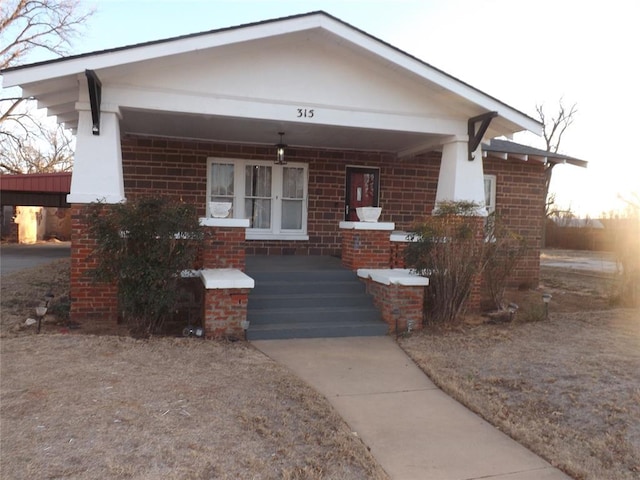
[{"left": 122, "top": 137, "right": 440, "bottom": 255}]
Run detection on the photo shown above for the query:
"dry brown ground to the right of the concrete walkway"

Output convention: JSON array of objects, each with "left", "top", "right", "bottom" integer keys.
[{"left": 400, "top": 252, "right": 640, "bottom": 480}]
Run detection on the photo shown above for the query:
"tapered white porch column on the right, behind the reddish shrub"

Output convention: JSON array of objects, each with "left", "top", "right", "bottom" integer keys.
[{"left": 436, "top": 138, "right": 487, "bottom": 217}]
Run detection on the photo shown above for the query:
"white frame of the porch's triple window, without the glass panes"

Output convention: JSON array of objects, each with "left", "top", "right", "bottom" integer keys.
[{"left": 206, "top": 157, "right": 309, "bottom": 241}]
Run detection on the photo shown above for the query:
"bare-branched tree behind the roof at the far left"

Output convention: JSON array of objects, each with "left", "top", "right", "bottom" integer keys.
[{"left": 0, "top": 0, "right": 92, "bottom": 173}]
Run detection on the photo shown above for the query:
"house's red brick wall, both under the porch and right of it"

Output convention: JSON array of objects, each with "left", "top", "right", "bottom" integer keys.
[{"left": 122, "top": 137, "right": 544, "bottom": 285}]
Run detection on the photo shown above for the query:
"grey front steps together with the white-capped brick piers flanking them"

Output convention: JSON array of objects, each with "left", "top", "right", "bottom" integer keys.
[{"left": 198, "top": 219, "right": 428, "bottom": 339}]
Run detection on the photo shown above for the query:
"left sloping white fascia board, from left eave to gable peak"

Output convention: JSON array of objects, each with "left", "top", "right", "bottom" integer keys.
[{"left": 3, "top": 15, "right": 319, "bottom": 87}]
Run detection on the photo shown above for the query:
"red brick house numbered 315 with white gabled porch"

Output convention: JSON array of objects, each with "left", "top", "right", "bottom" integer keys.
[{"left": 2, "top": 12, "right": 568, "bottom": 335}]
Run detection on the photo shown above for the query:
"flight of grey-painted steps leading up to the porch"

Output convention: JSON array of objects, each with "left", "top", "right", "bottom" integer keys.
[{"left": 246, "top": 257, "right": 389, "bottom": 340}]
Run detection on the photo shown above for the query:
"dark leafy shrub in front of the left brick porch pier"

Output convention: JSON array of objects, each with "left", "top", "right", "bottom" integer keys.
[{"left": 89, "top": 197, "right": 204, "bottom": 336}]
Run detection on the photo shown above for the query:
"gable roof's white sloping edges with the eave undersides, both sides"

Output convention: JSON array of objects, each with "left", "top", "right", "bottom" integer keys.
[{"left": 1, "top": 11, "right": 541, "bottom": 148}]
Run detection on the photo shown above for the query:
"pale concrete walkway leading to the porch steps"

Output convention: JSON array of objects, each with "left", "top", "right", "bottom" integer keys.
[{"left": 252, "top": 337, "right": 569, "bottom": 480}]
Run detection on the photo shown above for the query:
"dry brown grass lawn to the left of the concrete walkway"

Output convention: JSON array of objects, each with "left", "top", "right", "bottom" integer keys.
[{"left": 0, "top": 261, "right": 387, "bottom": 480}]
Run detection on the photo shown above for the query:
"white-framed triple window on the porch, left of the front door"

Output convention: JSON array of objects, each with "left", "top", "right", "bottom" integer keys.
[{"left": 207, "top": 159, "right": 309, "bottom": 240}]
